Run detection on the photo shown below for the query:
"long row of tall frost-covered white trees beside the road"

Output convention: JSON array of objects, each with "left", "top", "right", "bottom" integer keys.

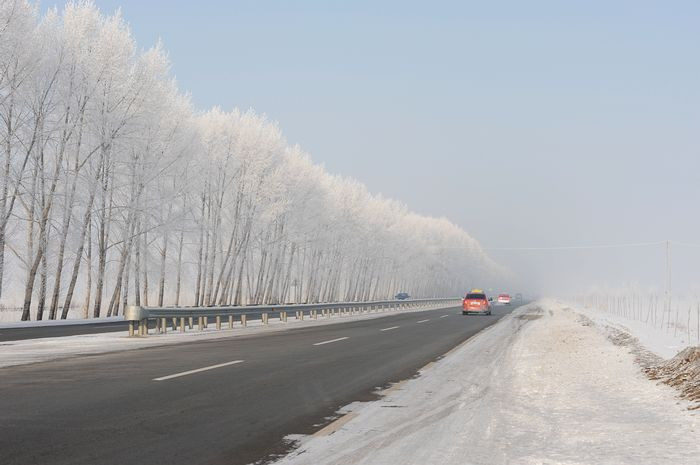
[{"left": 0, "top": 0, "right": 499, "bottom": 320}]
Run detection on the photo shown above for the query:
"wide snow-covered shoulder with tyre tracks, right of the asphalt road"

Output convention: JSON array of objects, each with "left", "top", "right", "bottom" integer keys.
[{"left": 278, "top": 301, "right": 700, "bottom": 465}]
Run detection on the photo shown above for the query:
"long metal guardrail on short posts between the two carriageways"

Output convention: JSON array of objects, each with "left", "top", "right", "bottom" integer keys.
[{"left": 124, "top": 298, "right": 462, "bottom": 336}]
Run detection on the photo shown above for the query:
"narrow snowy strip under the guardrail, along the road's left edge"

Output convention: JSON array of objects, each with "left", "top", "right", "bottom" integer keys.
[{"left": 0, "top": 305, "right": 454, "bottom": 368}]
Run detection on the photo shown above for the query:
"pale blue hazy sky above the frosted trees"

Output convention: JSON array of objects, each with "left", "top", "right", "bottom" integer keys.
[{"left": 43, "top": 0, "right": 700, "bottom": 292}]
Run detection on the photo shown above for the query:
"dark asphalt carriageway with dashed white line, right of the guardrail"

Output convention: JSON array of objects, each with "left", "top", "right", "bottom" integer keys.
[{"left": 0, "top": 306, "right": 515, "bottom": 465}]
